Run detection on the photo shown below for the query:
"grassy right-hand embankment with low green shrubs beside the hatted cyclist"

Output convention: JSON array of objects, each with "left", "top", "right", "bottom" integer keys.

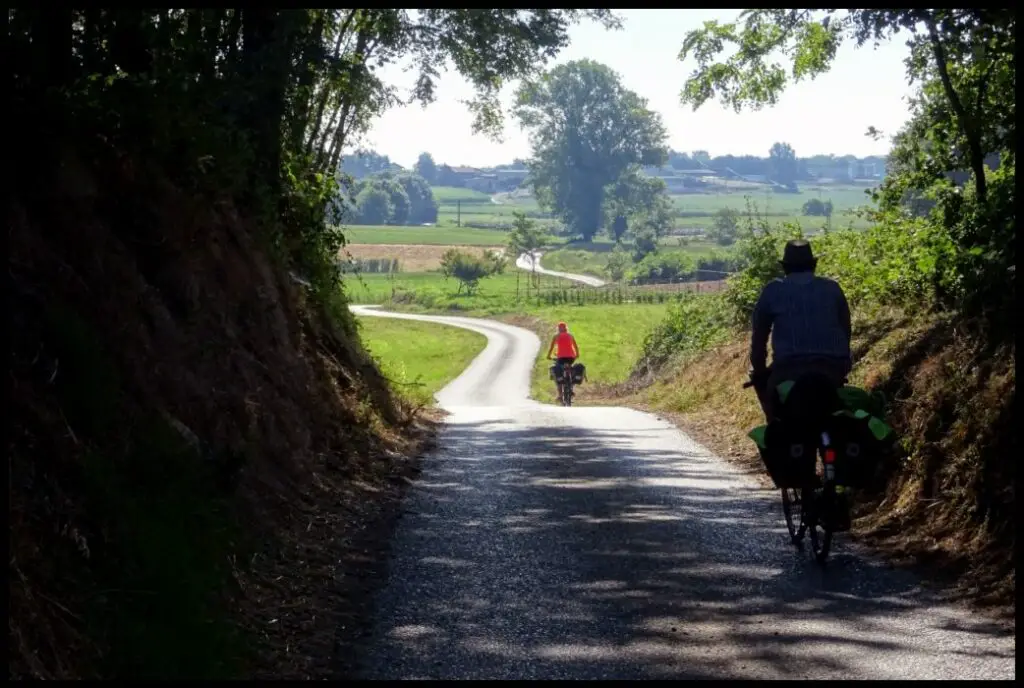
[{"left": 605, "top": 222, "right": 1016, "bottom": 611}]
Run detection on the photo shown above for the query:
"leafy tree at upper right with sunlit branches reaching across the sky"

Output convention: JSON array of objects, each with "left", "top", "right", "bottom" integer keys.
[{"left": 680, "top": 7, "right": 1017, "bottom": 319}]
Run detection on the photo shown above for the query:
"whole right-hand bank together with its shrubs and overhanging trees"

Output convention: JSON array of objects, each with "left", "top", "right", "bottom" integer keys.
[{"left": 621, "top": 10, "right": 1016, "bottom": 605}]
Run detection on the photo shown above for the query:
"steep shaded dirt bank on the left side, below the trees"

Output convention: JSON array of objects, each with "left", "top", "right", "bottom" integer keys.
[{"left": 7, "top": 153, "right": 432, "bottom": 679}]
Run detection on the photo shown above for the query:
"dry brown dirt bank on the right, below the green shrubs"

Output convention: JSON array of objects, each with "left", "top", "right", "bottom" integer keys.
[{"left": 593, "top": 312, "right": 1016, "bottom": 617}]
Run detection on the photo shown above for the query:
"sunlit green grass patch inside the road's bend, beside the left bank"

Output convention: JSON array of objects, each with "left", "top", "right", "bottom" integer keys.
[{"left": 356, "top": 316, "right": 487, "bottom": 405}]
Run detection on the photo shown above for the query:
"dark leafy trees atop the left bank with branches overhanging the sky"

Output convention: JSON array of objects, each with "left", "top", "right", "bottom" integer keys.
[{"left": 8, "top": 6, "right": 618, "bottom": 290}]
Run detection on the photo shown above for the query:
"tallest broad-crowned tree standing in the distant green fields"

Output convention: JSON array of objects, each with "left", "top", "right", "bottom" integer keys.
[{"left": 514, "top": 59, "right": 668, "bottom": 240}]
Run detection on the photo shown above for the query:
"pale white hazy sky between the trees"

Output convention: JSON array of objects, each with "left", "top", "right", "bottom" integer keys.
[{"left": 360, "top": 9, "right": 911, "bottom": 167}]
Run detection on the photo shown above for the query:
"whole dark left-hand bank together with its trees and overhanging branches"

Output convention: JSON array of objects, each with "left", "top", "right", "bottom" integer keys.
[{"left": 7, "top": 6, "right": 609, "bottom": 679}]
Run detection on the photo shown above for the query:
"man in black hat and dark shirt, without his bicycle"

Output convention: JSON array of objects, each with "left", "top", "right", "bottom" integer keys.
[{"left": 751, "top": 240, "right": 851, "bottom": 422}]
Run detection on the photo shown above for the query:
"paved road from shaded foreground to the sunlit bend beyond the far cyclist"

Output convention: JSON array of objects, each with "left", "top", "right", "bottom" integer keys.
[{"left": 355, "top": 308, "right": 1016, "bottom": 679}]
